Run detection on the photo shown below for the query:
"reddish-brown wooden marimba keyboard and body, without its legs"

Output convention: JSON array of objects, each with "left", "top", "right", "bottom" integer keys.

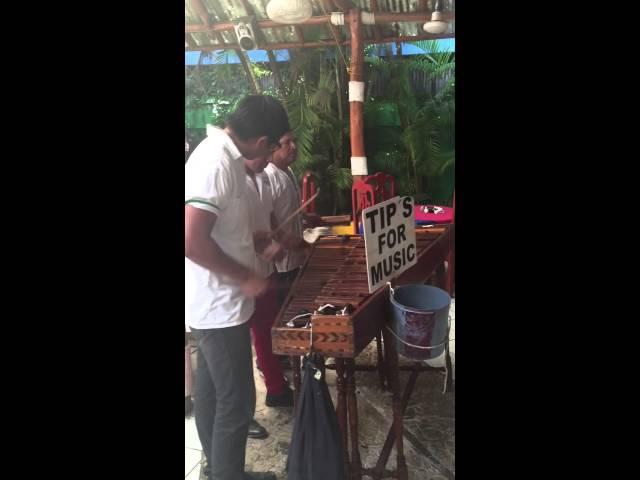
[{"left": 271, "top": 225, "right": 454, "bottom": 358}]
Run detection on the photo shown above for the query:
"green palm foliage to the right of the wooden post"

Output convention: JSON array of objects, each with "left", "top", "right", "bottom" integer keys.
[{"left": 365, "top": 40, "right": 455, "bottom": 203}]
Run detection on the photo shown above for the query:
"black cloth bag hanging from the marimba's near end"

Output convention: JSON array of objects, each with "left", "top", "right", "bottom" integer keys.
[{"left": 287, "top": 354, "right": 347, "bottom": 480}]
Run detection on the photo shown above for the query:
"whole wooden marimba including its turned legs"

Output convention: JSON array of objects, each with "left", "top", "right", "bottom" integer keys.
[{"left": 271, "top": 224, "right": 455, "bottom": 480}]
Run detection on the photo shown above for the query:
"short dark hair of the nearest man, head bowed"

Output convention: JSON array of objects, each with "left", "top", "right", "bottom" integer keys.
[{"left": 226, "top": 95, "right": 290, "bottom": 144}]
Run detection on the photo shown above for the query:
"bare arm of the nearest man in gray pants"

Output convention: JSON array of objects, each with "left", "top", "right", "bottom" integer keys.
[{"left": 184, "top": 205, "right": 267, "bottom": 297}]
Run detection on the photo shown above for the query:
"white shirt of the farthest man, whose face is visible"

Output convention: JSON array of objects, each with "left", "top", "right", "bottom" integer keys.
[{"left": 264, "top": 163, "right": 306, "bottom": 272}]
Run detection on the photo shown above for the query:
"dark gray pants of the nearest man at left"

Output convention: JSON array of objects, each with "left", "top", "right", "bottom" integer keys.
[{"left": 191, "top": 323, "right": 256, "bottom": 480}]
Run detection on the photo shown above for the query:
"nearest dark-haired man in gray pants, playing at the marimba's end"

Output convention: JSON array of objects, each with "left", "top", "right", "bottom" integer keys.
[{"left": 185, "top": 95, "right": 289, "bottom": 480}]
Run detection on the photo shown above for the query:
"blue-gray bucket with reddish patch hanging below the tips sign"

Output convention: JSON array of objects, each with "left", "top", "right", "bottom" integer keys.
[{"left": 391, "top": 285, "right": 451, "bottom": 360}]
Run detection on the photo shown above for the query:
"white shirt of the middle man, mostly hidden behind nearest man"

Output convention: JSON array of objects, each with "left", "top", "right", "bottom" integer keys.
[{"left": 246, "top": 172, "right": 275, "bottom": 278}]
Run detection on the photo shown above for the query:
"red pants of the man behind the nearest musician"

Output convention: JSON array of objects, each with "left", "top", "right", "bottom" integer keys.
[{"left": 249, "top": 276, "right": 285, "bottom": 395}]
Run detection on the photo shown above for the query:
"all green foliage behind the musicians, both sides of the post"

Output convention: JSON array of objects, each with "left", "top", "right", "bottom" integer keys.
[{"left": 185, "top": 41, "right": 455, "bottom": 215}]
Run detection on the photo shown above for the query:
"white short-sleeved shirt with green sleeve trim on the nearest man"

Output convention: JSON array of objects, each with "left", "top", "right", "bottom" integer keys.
[{"left": 184, "top": 129, "right": 255, "bottom": 329}]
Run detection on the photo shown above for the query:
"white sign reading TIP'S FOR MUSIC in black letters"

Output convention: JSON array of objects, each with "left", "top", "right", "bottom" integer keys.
[{"left": 362, "top": 197, "right": 418, "bottom": 293}]
